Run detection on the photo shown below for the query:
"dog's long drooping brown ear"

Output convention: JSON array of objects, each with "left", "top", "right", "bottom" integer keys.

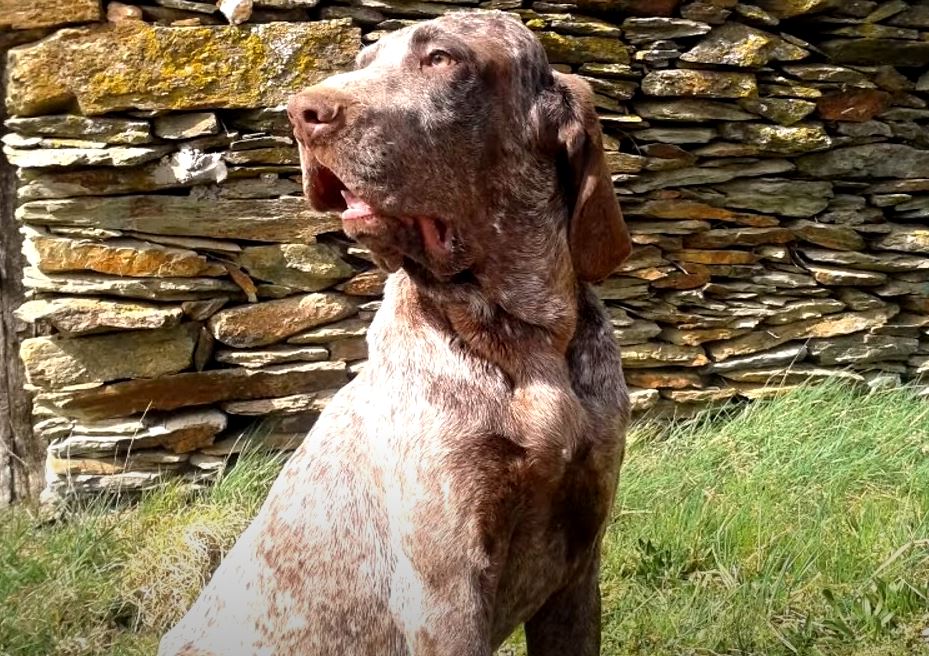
[{"left": 550, "top": 71, "right": 632, "bottom": 282}]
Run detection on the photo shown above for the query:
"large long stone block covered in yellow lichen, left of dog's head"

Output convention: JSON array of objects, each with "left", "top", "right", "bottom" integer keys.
[{"left": 6, "top": 20, "right": 360, "bottom": 116}]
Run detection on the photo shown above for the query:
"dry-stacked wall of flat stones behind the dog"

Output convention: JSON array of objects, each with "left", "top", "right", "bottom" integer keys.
[{"left": 0, "top": 0, "right": 929, "bottom": 500}]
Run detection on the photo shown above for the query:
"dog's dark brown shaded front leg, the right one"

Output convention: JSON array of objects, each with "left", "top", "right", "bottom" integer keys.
[{"left": 526, "top": 557, "right": 600, "bottom": 656}]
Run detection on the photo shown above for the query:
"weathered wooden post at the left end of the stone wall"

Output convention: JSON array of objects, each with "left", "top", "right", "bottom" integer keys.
[{"left": 0, "top": 33, "right": 45, "bottom": 506}]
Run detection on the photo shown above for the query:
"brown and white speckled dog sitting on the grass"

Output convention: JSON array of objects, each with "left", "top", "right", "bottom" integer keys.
[{"left": 159, "top": 12, "right": 629, "bottom": 656}]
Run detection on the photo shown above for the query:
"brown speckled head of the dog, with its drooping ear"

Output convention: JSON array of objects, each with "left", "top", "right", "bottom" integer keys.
[{"left": 288, "top": 12, "right": 629, "bottom": 281}]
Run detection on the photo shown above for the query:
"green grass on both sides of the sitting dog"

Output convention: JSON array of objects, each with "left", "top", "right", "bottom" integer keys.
[{"left": 0, "top": 385, "right": 929, "bottom": 656}]
